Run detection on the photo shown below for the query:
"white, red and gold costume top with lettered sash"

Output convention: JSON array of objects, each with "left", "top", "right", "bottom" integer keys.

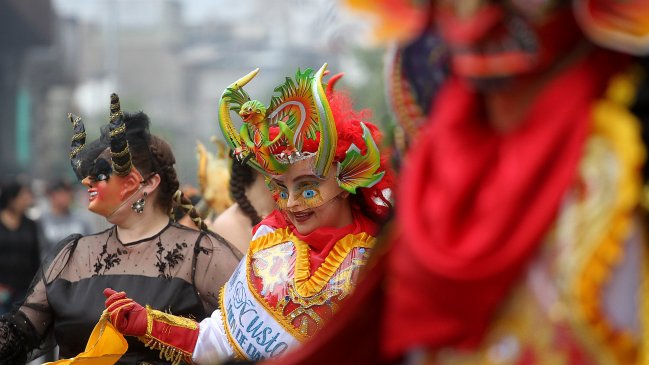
[{"left": 194, "top": 211, "right": 376, "bottom": 364}]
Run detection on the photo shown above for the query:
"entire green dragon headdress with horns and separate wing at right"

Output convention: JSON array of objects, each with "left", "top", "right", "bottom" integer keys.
[{"left": 219, "top": 64, "right": 384, "bottom": 193}]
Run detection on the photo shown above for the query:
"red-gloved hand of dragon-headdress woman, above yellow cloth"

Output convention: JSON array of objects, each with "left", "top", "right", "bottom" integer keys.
[{"left": 104, "top": 288, "right": 147, "bottom": 336}]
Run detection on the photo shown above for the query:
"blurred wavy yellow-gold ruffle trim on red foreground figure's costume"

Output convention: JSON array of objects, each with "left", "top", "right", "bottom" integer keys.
[{"left": 574, "top": 64, "right": 646, "bottom": 364}]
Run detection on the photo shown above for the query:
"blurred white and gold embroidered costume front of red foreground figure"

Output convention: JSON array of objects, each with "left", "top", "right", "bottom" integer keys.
[{"left": 425, "top": 64, "right": 649, "bottom": 365}]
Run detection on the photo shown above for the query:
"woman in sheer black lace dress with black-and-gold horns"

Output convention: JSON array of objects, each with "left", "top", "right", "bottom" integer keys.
[{"left": 0, "top": 94, "right": 241, "bottom": 365}]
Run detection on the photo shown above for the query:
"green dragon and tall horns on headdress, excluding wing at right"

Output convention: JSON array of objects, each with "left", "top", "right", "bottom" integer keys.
[{"left": 219, "top": 64, "right": 336, "bottom": 176}]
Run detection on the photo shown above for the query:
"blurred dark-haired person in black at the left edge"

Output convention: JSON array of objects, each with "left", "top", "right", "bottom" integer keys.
[{"left": 0, "top": 179, "right": 40, "bottom": 314}]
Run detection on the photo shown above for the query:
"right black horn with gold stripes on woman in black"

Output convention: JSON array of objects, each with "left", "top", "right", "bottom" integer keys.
[{"left": 110, "top": 93, "right": 131, "bottom": 176}]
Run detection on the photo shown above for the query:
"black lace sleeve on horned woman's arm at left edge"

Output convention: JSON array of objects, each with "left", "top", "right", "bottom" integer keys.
[{"left": 0, "top": 235, "right": 80, "bottom": 364}]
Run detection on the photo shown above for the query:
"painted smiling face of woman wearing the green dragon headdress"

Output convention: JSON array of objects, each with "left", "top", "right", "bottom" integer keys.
[{"left": 267, "top": 160, "right": 351, "bottom": 234}]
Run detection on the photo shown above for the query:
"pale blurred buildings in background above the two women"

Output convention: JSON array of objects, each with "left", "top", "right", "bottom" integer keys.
[{"left": 0, "top": 0, "right": 387, "bottom": 183}]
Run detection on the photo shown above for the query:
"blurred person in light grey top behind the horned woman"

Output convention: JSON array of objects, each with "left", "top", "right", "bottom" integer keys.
[{"left": 38, "top": 179, "right": 91, "bottom": 256}]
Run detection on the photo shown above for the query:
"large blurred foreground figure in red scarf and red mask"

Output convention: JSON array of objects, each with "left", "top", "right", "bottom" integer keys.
[{"left": 267, "top": 0, "right": 649, "bottom": 365}]
